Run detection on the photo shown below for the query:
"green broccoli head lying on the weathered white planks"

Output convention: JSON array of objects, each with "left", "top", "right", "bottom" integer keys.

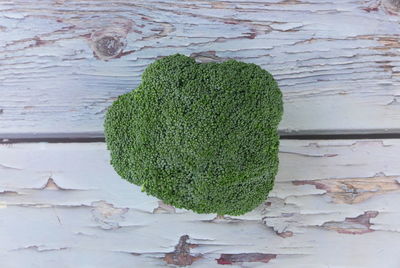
[{"left": 104, "top": 54, "right": 283, "bottom": 215}]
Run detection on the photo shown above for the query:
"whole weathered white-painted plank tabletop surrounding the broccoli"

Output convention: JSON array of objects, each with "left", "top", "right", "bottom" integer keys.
[{"left": 0, "top": 0, "right": 400, "bottom": 268}]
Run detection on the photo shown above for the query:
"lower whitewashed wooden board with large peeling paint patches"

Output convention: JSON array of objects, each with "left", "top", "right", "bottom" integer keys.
[{"left": 0, "top": 140, "right": 400, "bottom": 268}]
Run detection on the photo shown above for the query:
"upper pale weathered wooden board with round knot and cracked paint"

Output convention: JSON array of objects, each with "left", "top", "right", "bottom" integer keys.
[{"left": 0, "top": 0, "right": 400, "bottom": 137}]
